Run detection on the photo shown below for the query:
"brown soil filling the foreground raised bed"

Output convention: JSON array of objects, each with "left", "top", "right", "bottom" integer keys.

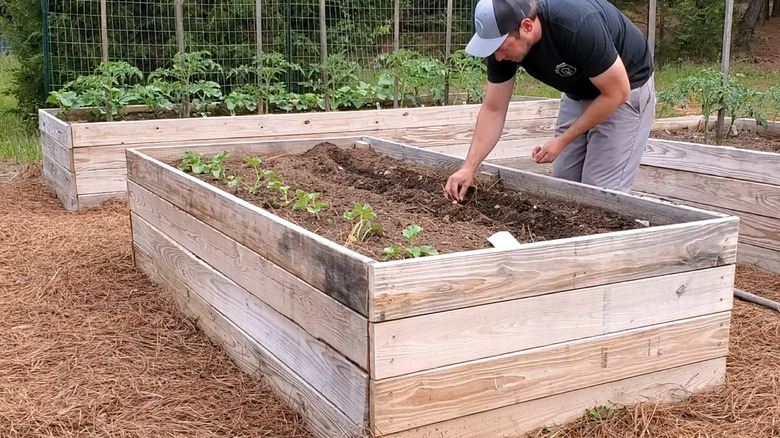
[{"left": 176, "top": 143, "right": 642, "bottom": 258}]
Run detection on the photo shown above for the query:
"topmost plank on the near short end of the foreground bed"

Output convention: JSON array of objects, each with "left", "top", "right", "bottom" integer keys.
[{"left": 369, "top": 217, "right": 739, "bottom": 322}]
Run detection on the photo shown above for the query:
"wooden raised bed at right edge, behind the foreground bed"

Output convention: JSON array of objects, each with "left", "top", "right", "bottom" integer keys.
[{"left": 634, "top": 138, "right": 780, "bottom": 273}]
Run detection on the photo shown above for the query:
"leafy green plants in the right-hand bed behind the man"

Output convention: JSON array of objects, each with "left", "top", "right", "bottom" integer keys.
[{"left": 658, "top": 68, "right": 780, "bottom": 142}]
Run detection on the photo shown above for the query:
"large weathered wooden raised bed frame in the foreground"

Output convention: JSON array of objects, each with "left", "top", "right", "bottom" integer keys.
[{"left": 127, "top": 137, "right": 739, "bottom": 437}]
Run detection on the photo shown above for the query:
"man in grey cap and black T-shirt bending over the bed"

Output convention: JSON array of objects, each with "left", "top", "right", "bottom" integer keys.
[{"left": 445, "top": 0, "right": 655, "bottom": 201}]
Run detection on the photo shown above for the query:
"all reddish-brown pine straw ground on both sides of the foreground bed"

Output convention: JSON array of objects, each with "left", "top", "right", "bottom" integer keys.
[{"left": 0, "top": 167, "right": 780, "bottom": 438}]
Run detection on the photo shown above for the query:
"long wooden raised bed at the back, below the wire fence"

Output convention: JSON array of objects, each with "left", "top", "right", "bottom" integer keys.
[{"left": 38, "top": 98, "right": 559, "bottom": 211}]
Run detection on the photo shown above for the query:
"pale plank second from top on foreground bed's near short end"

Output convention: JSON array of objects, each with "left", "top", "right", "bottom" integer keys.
[{"left": 371, "top": 265, "right": 734, "bottom": 380}]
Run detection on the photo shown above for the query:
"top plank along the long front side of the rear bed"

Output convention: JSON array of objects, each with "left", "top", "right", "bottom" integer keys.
[{"left": 72, "top": 99, "right": 560, "bottom": 147}]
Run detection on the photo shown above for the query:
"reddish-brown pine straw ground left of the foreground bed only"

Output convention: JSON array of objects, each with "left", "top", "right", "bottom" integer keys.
[{"left": 0, "top": 163, "right": 311, "bottom": 438}]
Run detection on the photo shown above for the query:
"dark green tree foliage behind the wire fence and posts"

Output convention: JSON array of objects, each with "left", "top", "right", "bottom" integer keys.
[{"left": 0, "top": 0, "right": 772, "bottom": 120}]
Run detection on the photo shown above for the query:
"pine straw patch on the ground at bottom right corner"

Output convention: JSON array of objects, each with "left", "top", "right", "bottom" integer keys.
[{"left": 533, "top": 265, "right": 780, "bottom": 438}]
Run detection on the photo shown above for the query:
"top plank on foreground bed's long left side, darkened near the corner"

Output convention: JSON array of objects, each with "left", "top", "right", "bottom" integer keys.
[{"left": 127, "top": 150, "right": 373, "bottom": 316}]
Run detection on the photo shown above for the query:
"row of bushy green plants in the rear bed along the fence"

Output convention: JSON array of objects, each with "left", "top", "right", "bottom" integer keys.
[{"left": 47, "top": 49, "right": 486, "bottom": 121}]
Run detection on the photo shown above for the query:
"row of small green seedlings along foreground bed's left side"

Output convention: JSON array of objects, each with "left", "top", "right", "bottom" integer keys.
[{"left": 174, "top": 151, "right": 438, "bottom": 260}]
